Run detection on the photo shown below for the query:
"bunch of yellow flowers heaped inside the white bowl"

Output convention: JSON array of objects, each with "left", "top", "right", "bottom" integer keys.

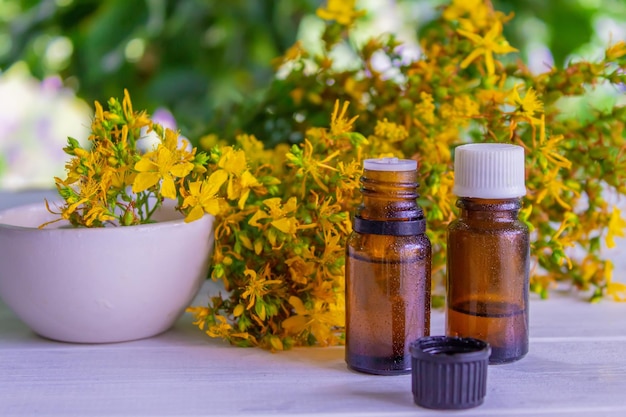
[{"left": 42, "top": 90, "right": 213, "bottom": 227}]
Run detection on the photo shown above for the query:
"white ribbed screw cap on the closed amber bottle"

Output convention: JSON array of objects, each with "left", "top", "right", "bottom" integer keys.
[{"left": 452, "top": 143, "right": 526, "bottom": 198}]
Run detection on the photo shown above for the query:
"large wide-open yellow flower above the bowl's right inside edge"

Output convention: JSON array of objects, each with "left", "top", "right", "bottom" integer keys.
[{"left": 133, "top": 145, "right": 193, "bottom": 200}]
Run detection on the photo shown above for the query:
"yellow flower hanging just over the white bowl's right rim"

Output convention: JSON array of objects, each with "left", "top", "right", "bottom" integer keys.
[{"left": 182, "top": 170, "right": 228, "bottom": 223}]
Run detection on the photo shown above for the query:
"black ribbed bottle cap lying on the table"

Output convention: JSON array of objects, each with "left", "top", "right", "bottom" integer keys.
[{"left": 410, "top": 336, "right": 491, "bottom": 409}]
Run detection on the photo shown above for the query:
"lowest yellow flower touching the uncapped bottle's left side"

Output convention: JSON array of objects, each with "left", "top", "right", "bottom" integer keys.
[{"left": 282, "top": 295, "right": 345, "bottom": 346}]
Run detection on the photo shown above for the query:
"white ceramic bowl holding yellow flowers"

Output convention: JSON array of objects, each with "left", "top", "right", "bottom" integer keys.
[{"left": 0, "top": 203, "right": 214, "bottom": 343}]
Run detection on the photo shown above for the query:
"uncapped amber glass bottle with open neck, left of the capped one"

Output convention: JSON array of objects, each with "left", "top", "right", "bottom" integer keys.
[{"left": 346, "top": 158, "right": 431, "bottom": 375}]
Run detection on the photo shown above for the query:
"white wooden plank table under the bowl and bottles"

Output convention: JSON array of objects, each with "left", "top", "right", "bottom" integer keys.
[{"left": 0, "top": 192, "right": 626, "bottom": 417}]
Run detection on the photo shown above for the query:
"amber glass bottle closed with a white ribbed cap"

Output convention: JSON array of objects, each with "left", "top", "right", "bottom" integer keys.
[{"left": 446, "top": 144, "right": 530, "bottom": 364}]
